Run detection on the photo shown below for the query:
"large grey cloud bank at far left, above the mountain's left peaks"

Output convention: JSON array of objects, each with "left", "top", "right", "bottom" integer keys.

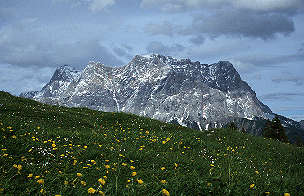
[{"left": 0, "top": 19, "right": 122, "bottom": 66}]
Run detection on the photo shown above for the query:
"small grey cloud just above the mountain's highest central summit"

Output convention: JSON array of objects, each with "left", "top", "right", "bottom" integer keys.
[{"left": 146, "top": 41, "right": 185, "bottom": 55}]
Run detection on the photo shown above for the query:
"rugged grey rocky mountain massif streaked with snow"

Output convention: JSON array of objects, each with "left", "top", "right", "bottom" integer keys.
[{"left": 20, "top": 54, "right": 273, "bottom": 130}]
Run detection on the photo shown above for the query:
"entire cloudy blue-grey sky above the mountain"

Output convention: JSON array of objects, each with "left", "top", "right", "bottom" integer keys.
[{"left": 0, "top": 0, "right": 304, "bottom": 120}]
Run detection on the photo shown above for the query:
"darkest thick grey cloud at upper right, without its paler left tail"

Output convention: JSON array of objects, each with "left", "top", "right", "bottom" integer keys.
[{"left": 190, "top": 10, "right": 295, "bottom": 39}]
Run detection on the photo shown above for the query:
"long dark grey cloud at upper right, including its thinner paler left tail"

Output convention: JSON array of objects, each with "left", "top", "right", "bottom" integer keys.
[{"left": 144, "top": 9, "right": 295, "bottom": 40}]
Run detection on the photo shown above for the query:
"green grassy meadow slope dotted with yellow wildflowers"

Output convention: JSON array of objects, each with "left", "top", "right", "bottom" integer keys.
[{"left": 0, "top": 92, "right": 304, "bottom": 195}]
